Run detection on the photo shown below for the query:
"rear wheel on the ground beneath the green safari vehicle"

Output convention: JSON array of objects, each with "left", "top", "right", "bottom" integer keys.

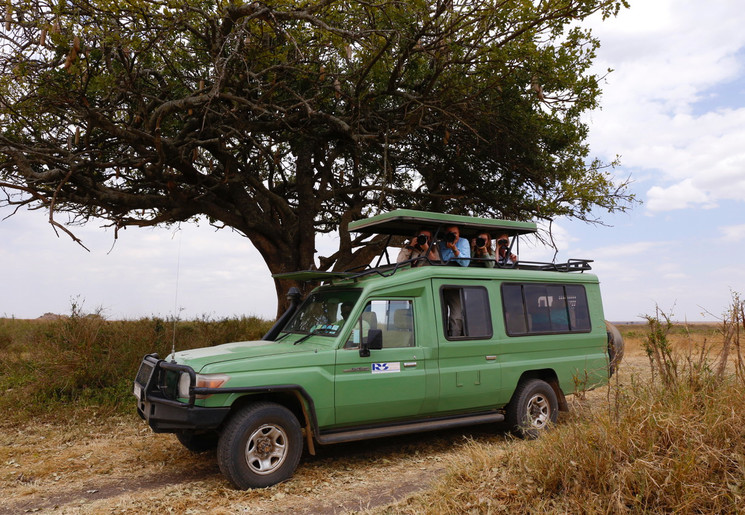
[{"left": 505, "top": 379, "right": 559, "bottom": 438}]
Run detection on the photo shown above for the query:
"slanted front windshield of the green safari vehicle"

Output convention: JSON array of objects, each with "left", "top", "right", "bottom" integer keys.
[{"left": 282, "top": 290, "right": 360, "bottom": 336}]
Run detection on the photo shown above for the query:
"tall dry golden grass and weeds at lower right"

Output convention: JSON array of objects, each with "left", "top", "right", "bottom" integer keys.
[{"left": 398, "top": 298, "right": 745, "bottom": 513}]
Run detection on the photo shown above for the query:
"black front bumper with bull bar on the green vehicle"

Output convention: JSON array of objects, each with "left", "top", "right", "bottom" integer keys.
[{"left": 134, "top": 354, "right": 230, "bottom": 433}]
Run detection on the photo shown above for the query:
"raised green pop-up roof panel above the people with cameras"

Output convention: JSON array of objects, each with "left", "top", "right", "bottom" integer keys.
[{"left": 348, "top": 209, "right": 537, "bottom": 238}]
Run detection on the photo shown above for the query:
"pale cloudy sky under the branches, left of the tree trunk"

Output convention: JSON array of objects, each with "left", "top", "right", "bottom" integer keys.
[{"left": 0, "top": 213, "right": 277, "bottom": 318}]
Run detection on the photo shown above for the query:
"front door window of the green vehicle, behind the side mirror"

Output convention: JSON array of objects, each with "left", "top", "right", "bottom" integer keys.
[{"left": 344, "top": 300, "right": 416, "bottom": 349}]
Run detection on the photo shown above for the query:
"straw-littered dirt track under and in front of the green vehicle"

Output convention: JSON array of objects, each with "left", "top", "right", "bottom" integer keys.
[{"left": 0, "top": 418, "right": 511, "bottom": 514}]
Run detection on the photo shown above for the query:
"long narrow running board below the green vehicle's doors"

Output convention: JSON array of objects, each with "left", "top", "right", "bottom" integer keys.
[{"left": 316, "top": 413, "right": 504, "bottom": 445}]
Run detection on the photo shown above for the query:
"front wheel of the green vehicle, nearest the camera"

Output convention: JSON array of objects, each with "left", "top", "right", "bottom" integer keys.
[{"left": 217, "top": 402, "right": 303, "bottom": 490}]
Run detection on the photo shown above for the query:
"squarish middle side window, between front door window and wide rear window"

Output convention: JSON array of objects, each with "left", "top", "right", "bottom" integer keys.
[{"left": 440, "top": 286, "right": 493, "bottom": 340}]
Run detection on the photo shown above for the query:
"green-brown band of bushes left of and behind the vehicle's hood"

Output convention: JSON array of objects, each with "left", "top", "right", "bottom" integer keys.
[{"left": 0, "top": 303, "right": 271, "bottom": 422}]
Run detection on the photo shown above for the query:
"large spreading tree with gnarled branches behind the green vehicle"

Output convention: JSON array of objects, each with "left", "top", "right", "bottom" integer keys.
[{"left": 0, "top": 0, "right": 633, "bottom": 309}]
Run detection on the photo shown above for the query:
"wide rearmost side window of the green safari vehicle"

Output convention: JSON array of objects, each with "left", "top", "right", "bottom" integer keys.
[{"left": 502, "top": 284, "right": 591, "bottom": 336}]
